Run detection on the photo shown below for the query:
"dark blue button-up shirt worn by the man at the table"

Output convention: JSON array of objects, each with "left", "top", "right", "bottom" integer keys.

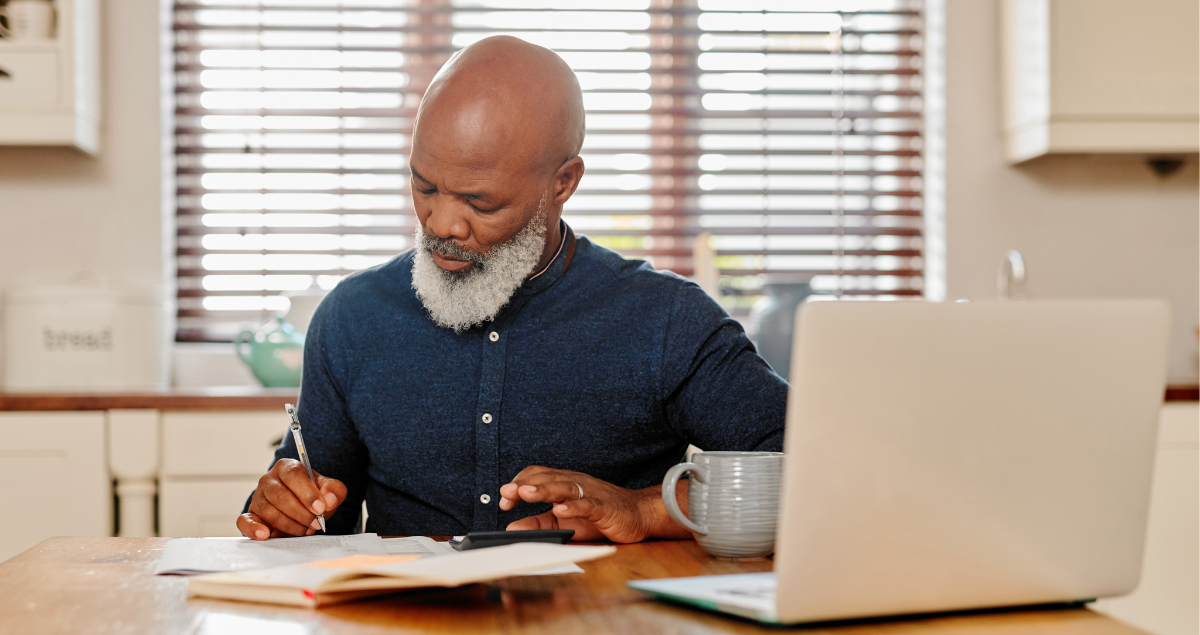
[{"left": 266, "top": 224, "right": 787, "bottom": 535}]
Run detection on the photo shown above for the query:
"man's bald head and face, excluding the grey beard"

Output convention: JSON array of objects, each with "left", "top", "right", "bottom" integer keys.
[{"left": 408, "top": 36, "right": 583, "bottom": 278}]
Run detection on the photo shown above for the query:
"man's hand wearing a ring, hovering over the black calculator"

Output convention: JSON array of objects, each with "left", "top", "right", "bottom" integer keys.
[{"left": 500, "top": 466, "right": 691, "bottom": 543}]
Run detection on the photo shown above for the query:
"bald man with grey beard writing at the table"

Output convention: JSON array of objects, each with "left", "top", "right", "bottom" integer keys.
[{"left": 238, "top": 36, "right": 786, "bottom": 543}]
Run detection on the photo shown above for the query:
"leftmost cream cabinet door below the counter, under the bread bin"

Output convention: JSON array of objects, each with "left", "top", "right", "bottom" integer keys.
[{"left": 0, "top": 412, "right": 113, "bottom": 561}]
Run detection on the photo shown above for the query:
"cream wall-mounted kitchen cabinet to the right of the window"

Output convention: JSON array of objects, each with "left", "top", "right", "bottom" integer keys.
[{"left": 1001, "top": 0, "right": 1200, "bottom": 163}]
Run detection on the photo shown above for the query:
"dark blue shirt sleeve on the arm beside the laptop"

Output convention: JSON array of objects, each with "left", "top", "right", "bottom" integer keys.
[{"left": 662, "top": 282, "right": 787, "bottom": 451}]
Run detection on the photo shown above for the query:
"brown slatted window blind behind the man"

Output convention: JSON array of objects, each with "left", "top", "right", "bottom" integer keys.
[{"left": 174, "top": 0, "right": 923, "bottom": 341}]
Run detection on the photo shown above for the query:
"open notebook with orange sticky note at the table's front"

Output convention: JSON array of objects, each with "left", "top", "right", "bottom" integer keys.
[{"left": 187, "top": 543, "right": 616, "bottom": 606}]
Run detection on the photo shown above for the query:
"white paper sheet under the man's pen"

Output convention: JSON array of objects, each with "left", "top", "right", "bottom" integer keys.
[{"left": 154, "top": 534, "right": 388, "bottom": 575}]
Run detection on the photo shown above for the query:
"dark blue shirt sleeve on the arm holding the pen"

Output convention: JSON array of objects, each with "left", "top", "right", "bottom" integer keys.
[{"left": 246, "top": 292, "right": 368, "bottom": 534}]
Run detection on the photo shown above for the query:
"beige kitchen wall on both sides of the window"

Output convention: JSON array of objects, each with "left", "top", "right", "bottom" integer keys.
[{"left": 0, "top": 0, "right": 1200, "bottom": 382}]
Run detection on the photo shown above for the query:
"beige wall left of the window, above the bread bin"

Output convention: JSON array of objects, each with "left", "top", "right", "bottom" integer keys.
[{"left": 0, "top": 1, "right": 174, "bottom": 295}]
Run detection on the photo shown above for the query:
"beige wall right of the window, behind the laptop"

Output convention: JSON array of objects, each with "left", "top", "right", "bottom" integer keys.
[{"left": 931, "top": 0, "right": 1200, "bottom": 383}]
